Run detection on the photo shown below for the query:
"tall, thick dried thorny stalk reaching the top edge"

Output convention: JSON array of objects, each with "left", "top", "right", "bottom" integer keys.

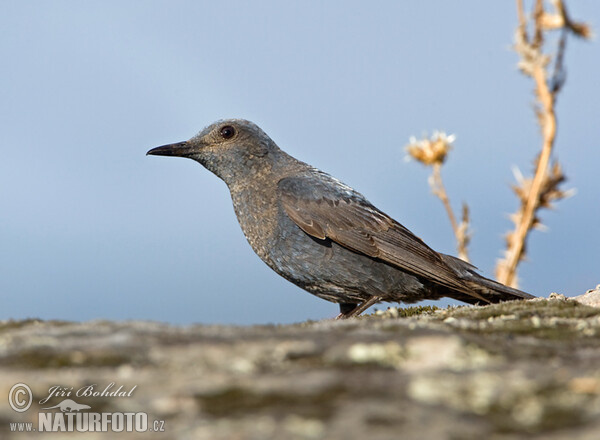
[{"left": 496, "top": 0, "right": 591, "bottom": 287}]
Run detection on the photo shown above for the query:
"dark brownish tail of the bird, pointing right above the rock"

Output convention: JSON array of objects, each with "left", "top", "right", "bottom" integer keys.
[{"left": 440, "top": 254, "right": 535, "bottom": 304}]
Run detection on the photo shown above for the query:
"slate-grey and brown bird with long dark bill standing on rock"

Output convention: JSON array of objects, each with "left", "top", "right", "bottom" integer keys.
[{"left": 147, "top": 119, "right": 534, "bottom": 319}]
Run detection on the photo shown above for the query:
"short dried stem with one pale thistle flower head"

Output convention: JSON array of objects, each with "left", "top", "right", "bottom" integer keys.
[{"left": 406, "top": 131, "right": 471, "bottom": 262}]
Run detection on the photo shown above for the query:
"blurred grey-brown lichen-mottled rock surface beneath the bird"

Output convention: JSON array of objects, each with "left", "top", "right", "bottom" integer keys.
[{"left": 0, "top": 290, "right": 600, "bottom": 440}]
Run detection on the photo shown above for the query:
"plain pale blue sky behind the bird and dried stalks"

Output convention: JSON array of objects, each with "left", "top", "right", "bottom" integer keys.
[{"left": 0, "top": 0, "right": 600, "bottom": 324}]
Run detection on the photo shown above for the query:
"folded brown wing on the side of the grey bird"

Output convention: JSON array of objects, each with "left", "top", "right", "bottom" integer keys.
[{"left": 278, "top": 174, "right": 487, "bottom": 302}]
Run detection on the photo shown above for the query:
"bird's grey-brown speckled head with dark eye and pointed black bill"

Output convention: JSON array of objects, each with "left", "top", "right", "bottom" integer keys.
[{"left": 146, "top": 119, "right": 282, "bottom": 185}]
